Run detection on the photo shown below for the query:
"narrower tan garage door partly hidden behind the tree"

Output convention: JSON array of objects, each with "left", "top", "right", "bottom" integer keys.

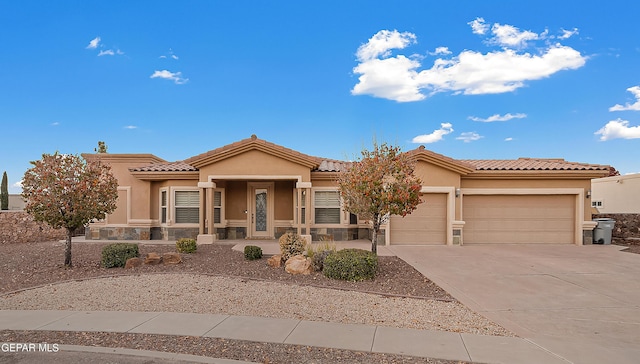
[{"left": 389, "top": 193, "right": 447, "bottom": 245}]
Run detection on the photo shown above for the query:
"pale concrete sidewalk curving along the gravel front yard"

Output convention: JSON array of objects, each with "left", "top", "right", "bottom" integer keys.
[{"left": 0, "top": 310, "right": 567, "bottom": 364}]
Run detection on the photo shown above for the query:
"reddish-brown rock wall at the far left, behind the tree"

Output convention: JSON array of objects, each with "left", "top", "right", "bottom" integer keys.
[{"left": 0, "top": 211, "right": 67, "bottom": 245}]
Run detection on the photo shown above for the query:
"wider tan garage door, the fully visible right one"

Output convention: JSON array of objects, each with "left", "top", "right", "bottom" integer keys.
[{"left": 462, "top": 195, "right": 576, "bottom": 244}]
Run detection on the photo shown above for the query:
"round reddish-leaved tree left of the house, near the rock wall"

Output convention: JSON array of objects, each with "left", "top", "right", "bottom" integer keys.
[{"left": 22, "top": 152, "right": 118, "bottom": 267}]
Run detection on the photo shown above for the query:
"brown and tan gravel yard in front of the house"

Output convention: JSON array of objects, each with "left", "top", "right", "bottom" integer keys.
[{"left": 0, "top": 242, "right": 512, "bottom": 363}]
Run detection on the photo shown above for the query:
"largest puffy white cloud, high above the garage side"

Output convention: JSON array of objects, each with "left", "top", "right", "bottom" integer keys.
[{"left": 351, "top": 18, "right": 587, "bottom": 102}]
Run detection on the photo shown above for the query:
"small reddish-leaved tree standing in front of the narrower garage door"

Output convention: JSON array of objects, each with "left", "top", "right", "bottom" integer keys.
[{"left": 338, "top": 143, "right": 422, "bottom": 253}]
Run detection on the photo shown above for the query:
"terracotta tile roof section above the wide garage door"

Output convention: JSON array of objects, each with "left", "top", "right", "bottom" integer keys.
[{"left": 461, "top": 158, "right": 609, "bottom": 171}]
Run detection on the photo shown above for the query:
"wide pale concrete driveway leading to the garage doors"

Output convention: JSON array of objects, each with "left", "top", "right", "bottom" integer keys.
[{"left": 388, "top": 245, "right": 640, "bottom": 363}]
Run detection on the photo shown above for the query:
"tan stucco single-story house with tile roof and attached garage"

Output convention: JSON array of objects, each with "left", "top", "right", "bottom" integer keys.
[{"left": 84, "top": 135, "right": 609, "bottom": 245}]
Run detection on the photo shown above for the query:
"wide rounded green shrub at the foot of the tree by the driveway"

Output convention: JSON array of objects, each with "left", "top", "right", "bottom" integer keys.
[{"left": 322, "top": 249, "right": 378, "bottom": 281}]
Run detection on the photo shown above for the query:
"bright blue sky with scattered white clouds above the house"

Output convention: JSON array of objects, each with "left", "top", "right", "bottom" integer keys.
[{"left": 0, "top": 0, "right": 640, "bottom": 193}]
